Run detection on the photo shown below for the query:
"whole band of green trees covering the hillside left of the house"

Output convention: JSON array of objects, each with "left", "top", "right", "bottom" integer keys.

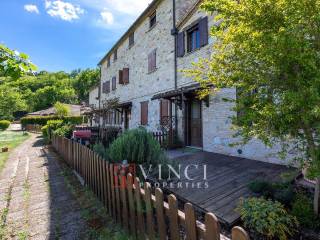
[{"left": 0, "top": 45, "right": 100, "bottom": 120}]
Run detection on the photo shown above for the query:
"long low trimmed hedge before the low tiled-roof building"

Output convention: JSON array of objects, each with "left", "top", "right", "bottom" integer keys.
[{"left": 20, "top": 116, "right": 87, "bottom": 126}]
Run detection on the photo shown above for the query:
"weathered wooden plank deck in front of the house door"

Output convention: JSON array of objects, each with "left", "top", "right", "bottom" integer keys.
[{"left": 166, "top": 152, "right": 292, "bottom": 226}]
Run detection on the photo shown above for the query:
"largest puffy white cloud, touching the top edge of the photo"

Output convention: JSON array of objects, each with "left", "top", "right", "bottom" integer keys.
[{"left": 45, "top": 0, "right": 84, "bottom": 22}]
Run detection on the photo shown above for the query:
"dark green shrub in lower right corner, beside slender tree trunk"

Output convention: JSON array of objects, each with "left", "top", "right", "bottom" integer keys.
[{"left": 291, "top": 193, "right": 320, "bottom": 230}]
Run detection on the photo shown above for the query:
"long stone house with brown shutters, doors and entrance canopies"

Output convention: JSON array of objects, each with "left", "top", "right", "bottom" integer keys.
[{"left": 90, "top": 0, "right": 290, "bottom": 163}]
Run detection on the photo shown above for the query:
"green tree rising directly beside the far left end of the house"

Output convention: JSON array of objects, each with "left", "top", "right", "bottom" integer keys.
[{"left": 72, "top": 69, "right": 100, "bottom": 101}]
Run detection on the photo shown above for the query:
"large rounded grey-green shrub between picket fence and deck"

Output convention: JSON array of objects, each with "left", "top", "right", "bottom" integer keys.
[{"left": 107, "top": 128, "right": 167, "bottom": 165}]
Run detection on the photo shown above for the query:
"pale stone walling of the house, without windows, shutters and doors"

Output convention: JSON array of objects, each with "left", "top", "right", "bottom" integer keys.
[{"left": 90, "top": 0, "right": 290, "bottom": 163}]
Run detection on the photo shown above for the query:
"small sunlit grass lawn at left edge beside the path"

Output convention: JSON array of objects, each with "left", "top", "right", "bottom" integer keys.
[{"left": 0, "top": 131, "right": 30, "bottom": 172}]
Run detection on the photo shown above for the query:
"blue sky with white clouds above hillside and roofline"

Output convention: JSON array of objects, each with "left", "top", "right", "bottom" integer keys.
[{"left": 0, "top": 0, "right": 151, "bottom": 72}]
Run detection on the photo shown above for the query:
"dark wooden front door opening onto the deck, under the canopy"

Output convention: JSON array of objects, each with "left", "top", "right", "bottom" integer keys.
[{"left": 189, "top": 100, "right": 202, "bottom": 147}]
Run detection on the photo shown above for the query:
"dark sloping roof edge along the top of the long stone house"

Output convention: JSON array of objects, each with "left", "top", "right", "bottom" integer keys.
[{"left": 98, "top": 0, "right": 162, "bottom": 66}]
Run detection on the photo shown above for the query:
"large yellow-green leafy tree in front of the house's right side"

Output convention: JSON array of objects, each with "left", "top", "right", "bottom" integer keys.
[{"left": 186, "top": 0, "right": 320, "bottom": 214}]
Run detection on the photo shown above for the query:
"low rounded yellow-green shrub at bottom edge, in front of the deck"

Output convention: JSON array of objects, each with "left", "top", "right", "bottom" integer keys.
[{"left": 238, "top": 198, "right": 298, "bottom": 240}]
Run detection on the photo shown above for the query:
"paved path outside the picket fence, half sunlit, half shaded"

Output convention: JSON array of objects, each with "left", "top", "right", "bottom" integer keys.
[{"left": 0, "top": 134, "right": 86, "bottom": 239}]
